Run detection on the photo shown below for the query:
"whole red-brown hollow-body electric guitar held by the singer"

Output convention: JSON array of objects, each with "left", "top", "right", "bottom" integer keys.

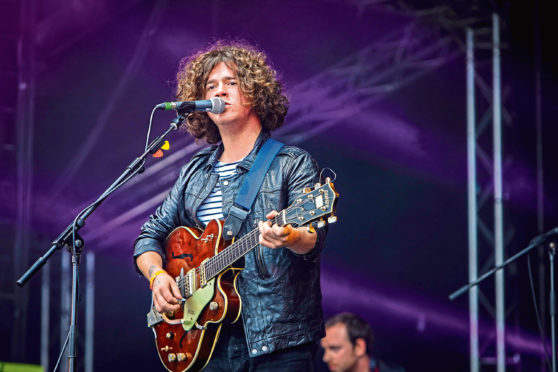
[{"left": 147, "top": 179, "right": 339, "bottom": 372}]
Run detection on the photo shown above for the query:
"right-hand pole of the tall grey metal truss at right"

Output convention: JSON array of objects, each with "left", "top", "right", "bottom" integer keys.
[{"left": 492, "top": 14, "right": 506, "bottom": 372}]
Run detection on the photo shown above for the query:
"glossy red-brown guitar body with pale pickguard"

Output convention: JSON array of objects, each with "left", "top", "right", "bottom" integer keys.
[{"left": 152, "top": 220, "right": 241, "bottom": 372}]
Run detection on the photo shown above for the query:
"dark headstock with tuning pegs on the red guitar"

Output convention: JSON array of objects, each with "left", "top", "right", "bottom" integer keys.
[{"left": 283, "top": 178, "right": 339, "bottom": 227}]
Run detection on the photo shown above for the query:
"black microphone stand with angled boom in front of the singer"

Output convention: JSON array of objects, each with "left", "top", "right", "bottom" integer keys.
[{"left": 17, "top": 114, "right": 185, "bottom": 372}]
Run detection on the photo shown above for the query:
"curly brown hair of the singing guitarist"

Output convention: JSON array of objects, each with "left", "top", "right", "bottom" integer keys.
[{"left": 176, "top": 40, "right": 289, "bottom": 144}]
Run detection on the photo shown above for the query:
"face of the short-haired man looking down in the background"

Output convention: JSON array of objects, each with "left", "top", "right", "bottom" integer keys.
[{"left": 321, "top": 323, "right": 361, "bottom": 372}]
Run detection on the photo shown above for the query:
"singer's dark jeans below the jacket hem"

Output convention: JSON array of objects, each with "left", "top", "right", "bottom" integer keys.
[{"left": 203, "top": 320, "right": 318, "bottom": 372}]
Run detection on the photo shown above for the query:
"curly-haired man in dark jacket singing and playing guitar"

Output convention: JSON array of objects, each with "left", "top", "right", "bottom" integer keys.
[{"left": 134, "top": 42, "right": 326, "bottom": 371}]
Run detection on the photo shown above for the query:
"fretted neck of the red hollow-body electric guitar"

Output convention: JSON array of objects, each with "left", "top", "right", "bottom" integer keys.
[{"left": 204, "top": 212, "right": 286, "bottom": 280}]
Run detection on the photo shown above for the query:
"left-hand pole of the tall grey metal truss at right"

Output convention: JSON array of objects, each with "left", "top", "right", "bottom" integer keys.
[{"left": 467, "top": 28, "right": 479, "bottom": 372}]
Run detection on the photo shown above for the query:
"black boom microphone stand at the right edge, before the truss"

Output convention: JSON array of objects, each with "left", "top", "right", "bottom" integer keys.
[{"left": 449, "top": 227, "right": 558, "bottom": 372}]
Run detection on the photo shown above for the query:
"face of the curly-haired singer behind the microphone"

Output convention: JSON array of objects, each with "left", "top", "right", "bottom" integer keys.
[{"left": 205, "top": 62, "right": 252, "bottom": 128}]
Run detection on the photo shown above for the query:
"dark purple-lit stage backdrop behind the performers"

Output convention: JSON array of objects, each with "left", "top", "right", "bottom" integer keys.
[{"left": 0, "top": 0, "right": 558, "bottom": 372}]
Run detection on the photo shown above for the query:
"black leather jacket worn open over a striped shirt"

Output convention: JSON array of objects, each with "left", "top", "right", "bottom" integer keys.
[{"left": 134, "top": 131, "right": 326, "bottom": 356}]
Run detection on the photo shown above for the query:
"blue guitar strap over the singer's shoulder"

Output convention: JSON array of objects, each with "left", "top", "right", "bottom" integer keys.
[{"left": 224, "top": 138, "right": 284, "bottom": 240}]
